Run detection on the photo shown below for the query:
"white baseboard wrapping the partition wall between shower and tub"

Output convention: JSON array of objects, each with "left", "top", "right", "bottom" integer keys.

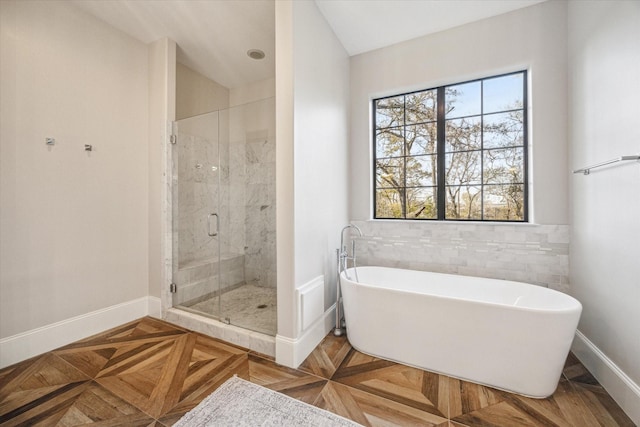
[{"left": 276, "top": 304, "right": 336, "bottom": 368}]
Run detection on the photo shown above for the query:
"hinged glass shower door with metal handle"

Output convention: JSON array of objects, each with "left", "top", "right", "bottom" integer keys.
[{"left": 171, "top": 112, "right": 222, "bottom": 319}]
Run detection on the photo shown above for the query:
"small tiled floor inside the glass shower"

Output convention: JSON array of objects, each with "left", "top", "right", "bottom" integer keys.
[{"left": 186, "top": 282, "right": 277, "bottom": 335}]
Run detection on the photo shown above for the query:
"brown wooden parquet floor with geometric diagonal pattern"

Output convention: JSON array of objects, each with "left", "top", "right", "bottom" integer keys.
[{"left": 0, "top": 317, "right": 633, "bottom": 427}]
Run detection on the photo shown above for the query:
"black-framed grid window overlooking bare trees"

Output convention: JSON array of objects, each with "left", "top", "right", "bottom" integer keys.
[{"left": 373, "top": 71, "right": 527, "bottom": 222}]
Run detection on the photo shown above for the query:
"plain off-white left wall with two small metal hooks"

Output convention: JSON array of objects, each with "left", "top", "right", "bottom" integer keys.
[{"left": 0, "top": 1, "right": 148, "bottom": 337}]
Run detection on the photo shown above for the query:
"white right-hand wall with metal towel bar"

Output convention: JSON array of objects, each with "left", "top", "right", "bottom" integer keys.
[{"left": 568, "top": 1, "right": 640, "bottom": 424}]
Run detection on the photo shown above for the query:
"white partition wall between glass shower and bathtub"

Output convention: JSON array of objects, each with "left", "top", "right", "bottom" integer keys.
[{"left": 276, "top": 1, "right": 349, "bottom": 357}]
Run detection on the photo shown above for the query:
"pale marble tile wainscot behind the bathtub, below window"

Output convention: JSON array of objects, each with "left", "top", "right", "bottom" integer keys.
[{"left": 352, "top": 221, "right": 569, "bottom": 292}]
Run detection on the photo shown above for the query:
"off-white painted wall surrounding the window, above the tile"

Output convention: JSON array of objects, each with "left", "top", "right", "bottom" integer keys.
[{"left": 349, "top": 1, "right": 568, "bottom": 224}]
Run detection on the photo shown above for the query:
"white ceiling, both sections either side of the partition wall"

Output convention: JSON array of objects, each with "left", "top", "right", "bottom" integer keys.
[{"left": 71, "top": 0, "right": 545, "bottom": 88}]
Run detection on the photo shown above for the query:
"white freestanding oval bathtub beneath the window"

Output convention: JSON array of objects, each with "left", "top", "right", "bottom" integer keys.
[{"left": 340, "top": 267, "right": 582, "bottom": 398}]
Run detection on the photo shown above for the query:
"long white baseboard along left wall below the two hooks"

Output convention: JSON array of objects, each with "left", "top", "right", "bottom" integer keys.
[{"left": 0, "top": 297, "right": 161, "bottom": 368}]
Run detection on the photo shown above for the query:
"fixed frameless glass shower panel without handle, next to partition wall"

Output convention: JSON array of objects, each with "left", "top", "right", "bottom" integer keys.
[{"left": 219, "top": 98, "right": 277, "bottom": 335}]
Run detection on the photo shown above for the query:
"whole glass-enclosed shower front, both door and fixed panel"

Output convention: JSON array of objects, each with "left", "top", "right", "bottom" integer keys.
[{"left": 171, "top": 98, "right": 276, "bottom": 336}]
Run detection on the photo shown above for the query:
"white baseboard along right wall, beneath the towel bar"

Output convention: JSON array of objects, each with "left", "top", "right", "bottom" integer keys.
[{"left": 571, "top": 331, "right": 640, "bottom": 425}]
